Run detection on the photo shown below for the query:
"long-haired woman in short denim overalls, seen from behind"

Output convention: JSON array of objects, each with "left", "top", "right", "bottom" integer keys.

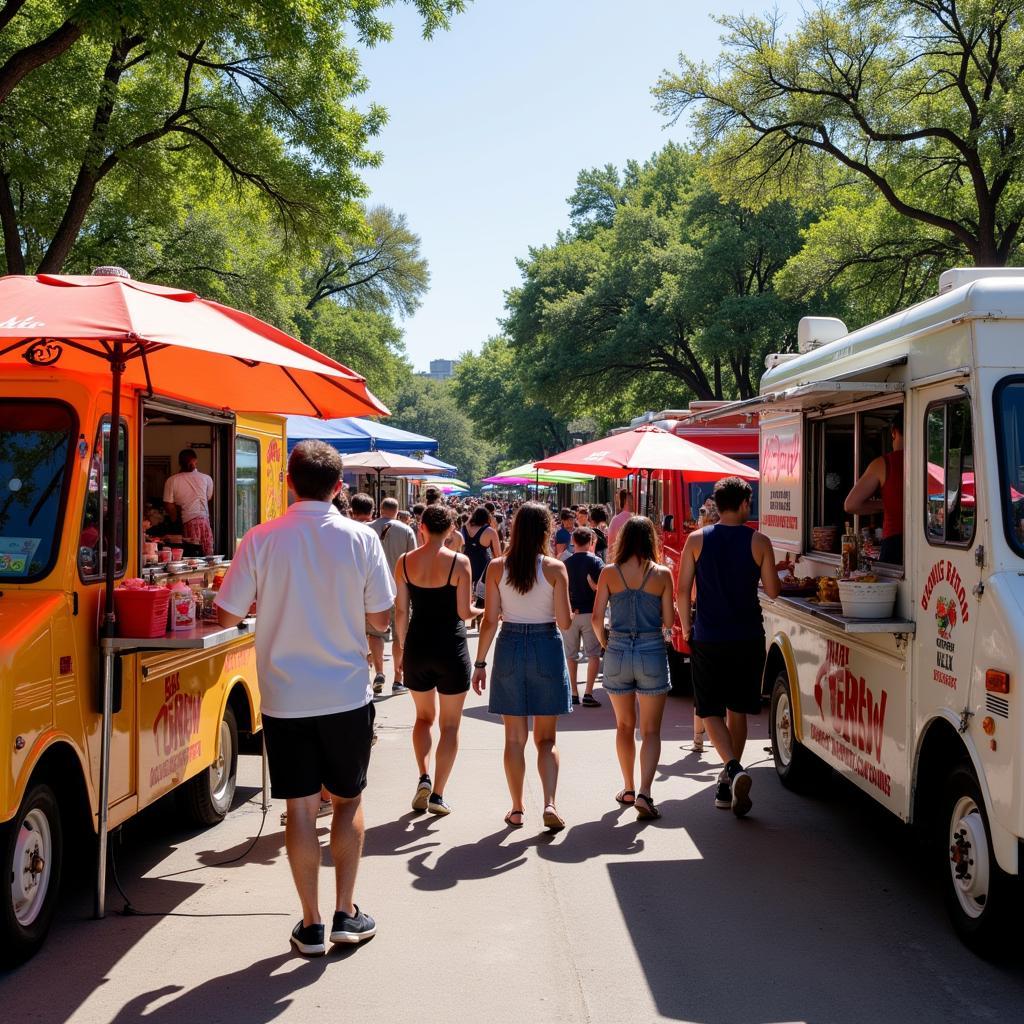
[{"left": 593, "top": 515, "right": 676, "bottom": 818}]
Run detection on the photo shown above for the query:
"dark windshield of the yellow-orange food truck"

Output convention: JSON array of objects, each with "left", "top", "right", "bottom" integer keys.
[{"left": 0, "top": 400, "right": 75, "bottom": 583}]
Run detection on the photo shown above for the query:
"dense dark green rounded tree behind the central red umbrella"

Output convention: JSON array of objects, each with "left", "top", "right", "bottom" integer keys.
[{"left": 505, "top": 145, "right": 806, "bottom": 407}]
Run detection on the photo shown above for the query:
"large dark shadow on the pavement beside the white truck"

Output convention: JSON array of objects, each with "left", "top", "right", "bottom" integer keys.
[{"left": 607, "top": 769, "right": 1024, "bottom": 1024}]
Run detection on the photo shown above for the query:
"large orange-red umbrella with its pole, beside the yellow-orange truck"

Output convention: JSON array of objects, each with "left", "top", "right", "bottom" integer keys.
[{"left": 0, "top": 267, "right": 387, "bottom": 918}]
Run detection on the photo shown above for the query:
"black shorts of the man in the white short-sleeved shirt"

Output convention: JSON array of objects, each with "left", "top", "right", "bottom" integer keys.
[{"left": 263, "top": 703, "right": 376, "bottom": 800}]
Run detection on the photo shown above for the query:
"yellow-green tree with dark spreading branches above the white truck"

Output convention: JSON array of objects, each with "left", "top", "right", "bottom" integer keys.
[{"left": 654, "top": 0, "right": 1024, "bottom": 266}]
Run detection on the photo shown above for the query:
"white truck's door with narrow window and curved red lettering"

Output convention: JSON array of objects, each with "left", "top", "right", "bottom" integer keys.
[{"left": 917, "top": 383, "right": 983, "bottom": 735}]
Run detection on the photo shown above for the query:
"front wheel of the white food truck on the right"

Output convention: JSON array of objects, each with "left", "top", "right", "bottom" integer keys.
[{"left": 936, "top": 763, "right": 1020, "bottom": 956}]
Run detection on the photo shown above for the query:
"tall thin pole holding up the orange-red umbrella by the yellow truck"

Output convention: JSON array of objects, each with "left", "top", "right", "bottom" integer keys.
[{"left": 94, "top": 342, "right": 124, "bottom": 920}]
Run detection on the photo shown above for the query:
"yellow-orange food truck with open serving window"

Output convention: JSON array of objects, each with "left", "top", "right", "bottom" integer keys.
[{"left": 0, "top": 366, "right": 286, "bottom": 959}]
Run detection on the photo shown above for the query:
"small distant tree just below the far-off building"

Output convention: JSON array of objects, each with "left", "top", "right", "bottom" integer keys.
[{"left": 388, "top": 377, "right": 495, "bottom": 484}]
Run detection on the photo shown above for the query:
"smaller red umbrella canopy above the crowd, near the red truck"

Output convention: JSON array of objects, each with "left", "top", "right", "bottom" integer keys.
[{"left": 537, "top": 426, "right": 759, "bottom": 481}]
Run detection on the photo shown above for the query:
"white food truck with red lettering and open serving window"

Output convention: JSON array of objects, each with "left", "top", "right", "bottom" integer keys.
[{"left": 684, "top": 269, "right": 1024, "bottom": 949}]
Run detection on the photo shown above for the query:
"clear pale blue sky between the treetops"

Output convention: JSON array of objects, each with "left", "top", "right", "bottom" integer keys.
[{"left": 364, "top": 0, "right": 798, "bottom": 370}]
